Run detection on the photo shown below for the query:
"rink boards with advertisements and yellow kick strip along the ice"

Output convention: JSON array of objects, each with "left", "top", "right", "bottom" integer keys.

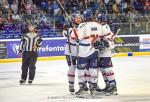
[{"left": 0, "top": 34, "right": 150, "bottom": 63}]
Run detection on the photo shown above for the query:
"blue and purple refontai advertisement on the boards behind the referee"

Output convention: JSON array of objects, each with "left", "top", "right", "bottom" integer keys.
[{"left": 7, "top": 39, "right": 66, "bottom": 58}]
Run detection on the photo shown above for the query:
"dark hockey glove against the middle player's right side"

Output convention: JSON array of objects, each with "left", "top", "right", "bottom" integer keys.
[{"left": 93, "top": 40, "right": 109, "bottom": 50}]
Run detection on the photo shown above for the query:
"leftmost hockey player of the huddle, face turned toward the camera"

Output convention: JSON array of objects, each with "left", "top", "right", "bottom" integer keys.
[{"left": 63, "top": 12, "right": 81, "bottom": 93}]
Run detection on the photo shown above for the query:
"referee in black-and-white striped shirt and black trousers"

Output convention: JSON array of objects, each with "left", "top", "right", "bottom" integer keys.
[{"left": 19, "top": 25, "right": 42, "bottom": 84}]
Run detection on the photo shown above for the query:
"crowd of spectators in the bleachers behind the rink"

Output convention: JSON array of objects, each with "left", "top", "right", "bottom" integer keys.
[{"left": 0, "top": 0, "right": 150, "bottom": 39}]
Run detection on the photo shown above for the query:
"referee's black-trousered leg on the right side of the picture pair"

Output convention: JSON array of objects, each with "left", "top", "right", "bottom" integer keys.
[{"left": 28, "top": 52, "right": 38, "bottom": 84}]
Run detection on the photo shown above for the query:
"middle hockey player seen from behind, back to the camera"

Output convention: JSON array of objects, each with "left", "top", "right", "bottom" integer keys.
[{"left": 76, "top": 10, "right": 113, "bottom": 95}]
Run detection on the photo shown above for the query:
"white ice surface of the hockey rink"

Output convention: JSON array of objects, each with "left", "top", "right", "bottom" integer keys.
[{"left": 0, "top": 56, "right": 150, "bottom": 102}]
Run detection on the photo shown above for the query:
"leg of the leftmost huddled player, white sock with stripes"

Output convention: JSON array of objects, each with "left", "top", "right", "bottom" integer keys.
[{"left": 66, "top": 55, "right": 76, "bottom": 93}]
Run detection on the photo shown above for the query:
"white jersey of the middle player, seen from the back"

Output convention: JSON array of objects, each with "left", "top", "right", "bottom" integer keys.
[{"left": 77, "top": 22, "right": 110, "bottom": 57}]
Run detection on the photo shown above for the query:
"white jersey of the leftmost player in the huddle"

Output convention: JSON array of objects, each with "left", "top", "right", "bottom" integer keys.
[{"left": 63, "top": 28, "right": 78, "bottom": 56}]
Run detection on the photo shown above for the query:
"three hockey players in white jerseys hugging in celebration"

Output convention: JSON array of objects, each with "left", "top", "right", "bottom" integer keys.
[{"left": 63, "top": 9, "right": 117, "bottom": 95}]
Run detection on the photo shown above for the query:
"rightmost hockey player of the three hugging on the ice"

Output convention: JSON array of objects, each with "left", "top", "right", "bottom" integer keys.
[{"left": 95, "top": 14, "right": 117, "bottom": 95}]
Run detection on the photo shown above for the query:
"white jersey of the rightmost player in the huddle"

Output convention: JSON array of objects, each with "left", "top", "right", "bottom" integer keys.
[{"left": 99, "top": 24, "right": 114, "bottom": 57}]
